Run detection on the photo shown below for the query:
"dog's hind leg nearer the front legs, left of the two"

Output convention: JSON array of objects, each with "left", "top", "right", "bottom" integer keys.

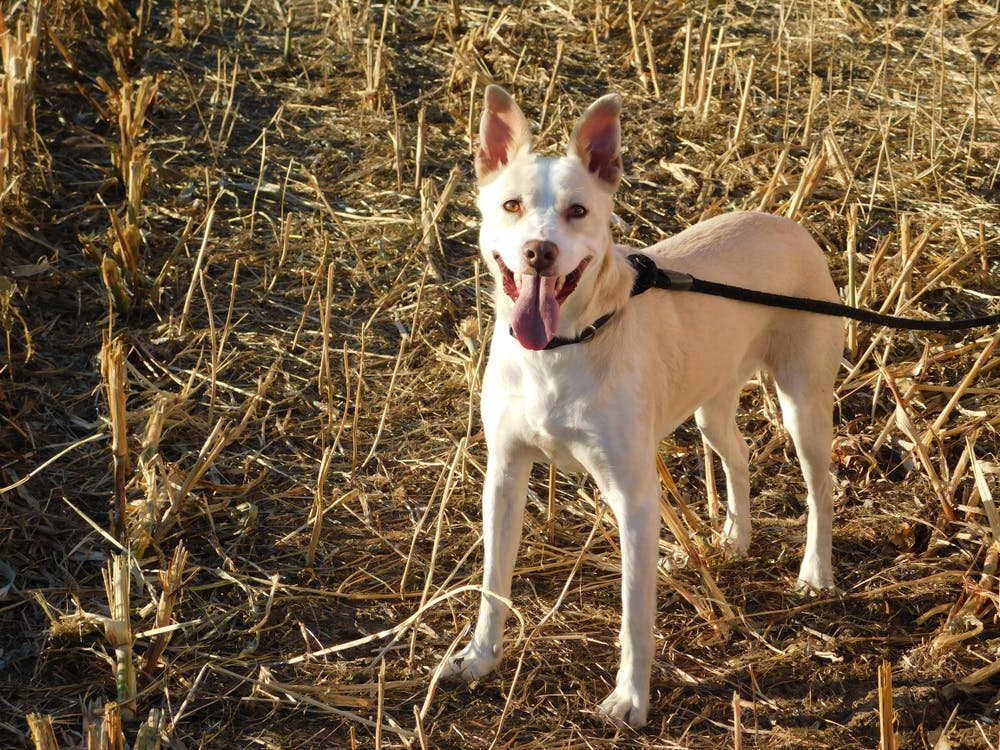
[{"left": 694, "top": 384, "right": 750, "bottom": 557}]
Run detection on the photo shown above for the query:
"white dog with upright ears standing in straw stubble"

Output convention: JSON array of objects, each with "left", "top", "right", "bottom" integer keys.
[{"left": 441, "top": 85, "right": 844, "bottom": 727}]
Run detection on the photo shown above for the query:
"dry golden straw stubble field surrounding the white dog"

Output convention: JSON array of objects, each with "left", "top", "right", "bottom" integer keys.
[{"left": 0, "top": 0, "right": 1000, "bottom": 749}]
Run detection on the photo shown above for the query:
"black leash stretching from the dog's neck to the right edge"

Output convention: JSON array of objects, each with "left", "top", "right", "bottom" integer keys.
[{"left": 628, "top": 253, "right": 1000, "bottom": 331}]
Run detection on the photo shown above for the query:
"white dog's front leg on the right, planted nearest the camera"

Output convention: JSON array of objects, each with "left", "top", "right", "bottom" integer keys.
[{"left": 598, "top": 470, "right": 660, "bottom": 727}]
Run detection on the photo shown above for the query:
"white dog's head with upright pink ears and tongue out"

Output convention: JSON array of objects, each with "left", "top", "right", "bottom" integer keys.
[{"left": 476, "top": 86, "right": 622, "bottom": 349}]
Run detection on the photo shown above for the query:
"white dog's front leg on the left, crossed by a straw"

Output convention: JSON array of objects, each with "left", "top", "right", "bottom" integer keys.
[{"left": 442, "top": 448, "right": 531, "bottom": 680}]
